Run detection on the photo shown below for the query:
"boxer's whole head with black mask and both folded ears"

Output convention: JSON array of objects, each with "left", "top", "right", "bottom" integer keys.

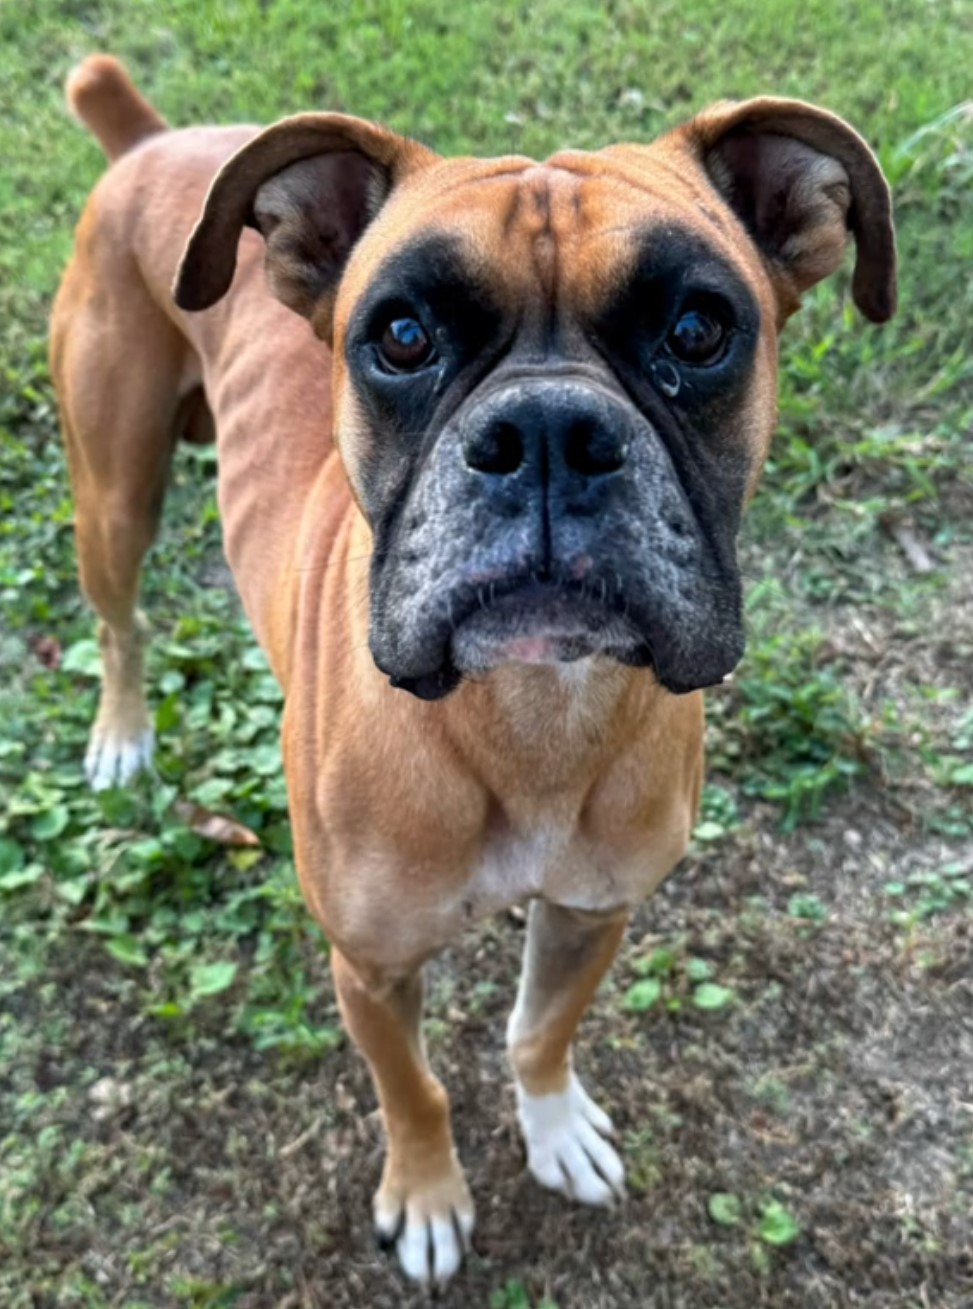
[{"left": 175, "top": 99, "right": 896, "bottom": 698}]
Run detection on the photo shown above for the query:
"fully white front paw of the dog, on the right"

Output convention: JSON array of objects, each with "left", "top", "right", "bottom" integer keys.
[{"left": 517, "top": 1073, "right": 625, "bottom": 1204}]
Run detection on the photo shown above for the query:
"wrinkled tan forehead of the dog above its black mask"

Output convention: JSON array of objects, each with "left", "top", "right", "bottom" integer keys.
[{"left": 339, "top": 147, "right": 769, "bottom": 327}]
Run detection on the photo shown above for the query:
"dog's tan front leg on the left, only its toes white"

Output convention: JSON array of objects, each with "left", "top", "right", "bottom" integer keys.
[{"left": 331, "top": 950, "right": 473, "bottom": 1285}]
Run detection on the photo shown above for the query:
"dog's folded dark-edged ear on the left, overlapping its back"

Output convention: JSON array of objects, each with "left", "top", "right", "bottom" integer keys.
[{"left": 173, "top": 114, "right": 436, "bottom": 331}]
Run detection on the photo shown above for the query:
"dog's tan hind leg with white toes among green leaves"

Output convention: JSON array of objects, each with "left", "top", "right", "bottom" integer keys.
[{"left": 51, "top": 263, "right": 186, "bottom": 789}]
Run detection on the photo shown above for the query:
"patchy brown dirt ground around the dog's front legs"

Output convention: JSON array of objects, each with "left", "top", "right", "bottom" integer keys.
[{"left": 4, "top": 780, "right": 973, "bottom": 1309}]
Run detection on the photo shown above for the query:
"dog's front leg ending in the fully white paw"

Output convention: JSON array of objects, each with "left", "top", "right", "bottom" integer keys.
[{"left": 507, "top": 901, "right": 629, "bottom": 1204}]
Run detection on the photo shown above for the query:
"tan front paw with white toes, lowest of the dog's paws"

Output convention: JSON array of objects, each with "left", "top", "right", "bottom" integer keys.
[{"left": 375, "top": 1164, "right": 474, "bottom": 1289}]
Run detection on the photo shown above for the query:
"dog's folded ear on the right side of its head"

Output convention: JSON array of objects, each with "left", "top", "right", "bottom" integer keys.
[{"left": 677, "top": 97, "right": 896, "bottom": 322}]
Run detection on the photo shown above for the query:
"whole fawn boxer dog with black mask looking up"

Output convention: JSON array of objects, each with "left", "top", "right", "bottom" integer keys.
[{"left": 52, "top": 56, "right": 894, "bottom": 1283}]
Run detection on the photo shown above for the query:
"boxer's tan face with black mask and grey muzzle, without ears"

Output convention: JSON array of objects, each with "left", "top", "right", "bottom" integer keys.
[{"left": 335, "top": 153, "right": 774, "bottom": 695}]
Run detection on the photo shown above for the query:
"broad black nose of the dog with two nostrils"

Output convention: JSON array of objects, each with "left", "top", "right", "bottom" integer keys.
[{"left": 464, "top": 382, "right": 629, "bottom": 484}]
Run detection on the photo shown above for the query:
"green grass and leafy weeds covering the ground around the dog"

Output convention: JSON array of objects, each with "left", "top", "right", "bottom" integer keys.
[{"left": 0, "top": 0, "right": 973, "bottom": 1309}]
